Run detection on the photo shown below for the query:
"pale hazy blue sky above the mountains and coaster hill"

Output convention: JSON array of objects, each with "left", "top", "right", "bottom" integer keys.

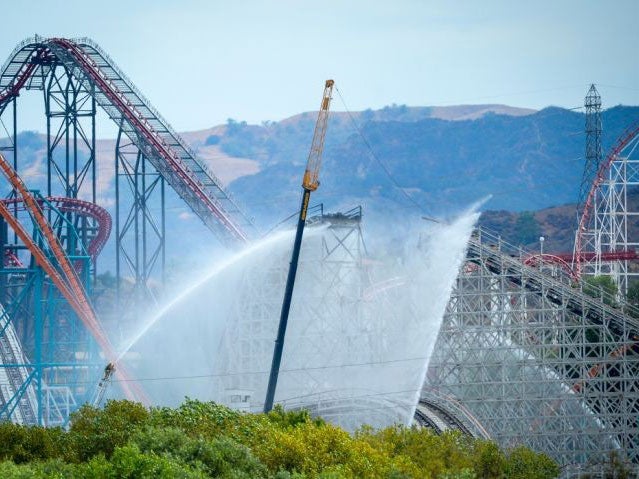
[{"left": 0, "top": 0, "right": 639, "bottom": 131}]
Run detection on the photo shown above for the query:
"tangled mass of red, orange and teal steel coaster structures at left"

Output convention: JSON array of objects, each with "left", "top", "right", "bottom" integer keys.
[{"left": 0, "top": 37, "right": 254, "bottom": 425}]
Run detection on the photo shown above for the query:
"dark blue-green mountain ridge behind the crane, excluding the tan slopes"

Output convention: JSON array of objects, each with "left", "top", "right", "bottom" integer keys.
[{"left": 221, "top": 106, "right": 639, "bottom": 227}]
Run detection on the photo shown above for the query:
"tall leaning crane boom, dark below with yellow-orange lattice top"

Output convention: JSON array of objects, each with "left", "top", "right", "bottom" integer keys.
[{"left": 264, "top": 80, "right": 335, "bottom": 413}]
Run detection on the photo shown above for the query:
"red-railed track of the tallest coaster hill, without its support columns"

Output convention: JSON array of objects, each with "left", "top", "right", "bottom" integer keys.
[{"left": 0, "top": 37, "right": 253, "bottom": 246}]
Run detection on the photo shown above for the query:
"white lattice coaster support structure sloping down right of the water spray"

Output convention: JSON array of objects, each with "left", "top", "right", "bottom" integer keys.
[{"left": 424, "top": 230, "right": 639, "bottom": 473}]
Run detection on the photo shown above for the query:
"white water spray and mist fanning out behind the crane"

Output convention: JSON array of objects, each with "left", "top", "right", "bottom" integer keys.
[{"left": 116, "top": 208, "right": 478, "bottom": 430}]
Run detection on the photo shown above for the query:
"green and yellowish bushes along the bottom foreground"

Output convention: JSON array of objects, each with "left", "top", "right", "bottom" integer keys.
[{"left": 0, "top": 399, "right": 559, "bottom": 479}]
